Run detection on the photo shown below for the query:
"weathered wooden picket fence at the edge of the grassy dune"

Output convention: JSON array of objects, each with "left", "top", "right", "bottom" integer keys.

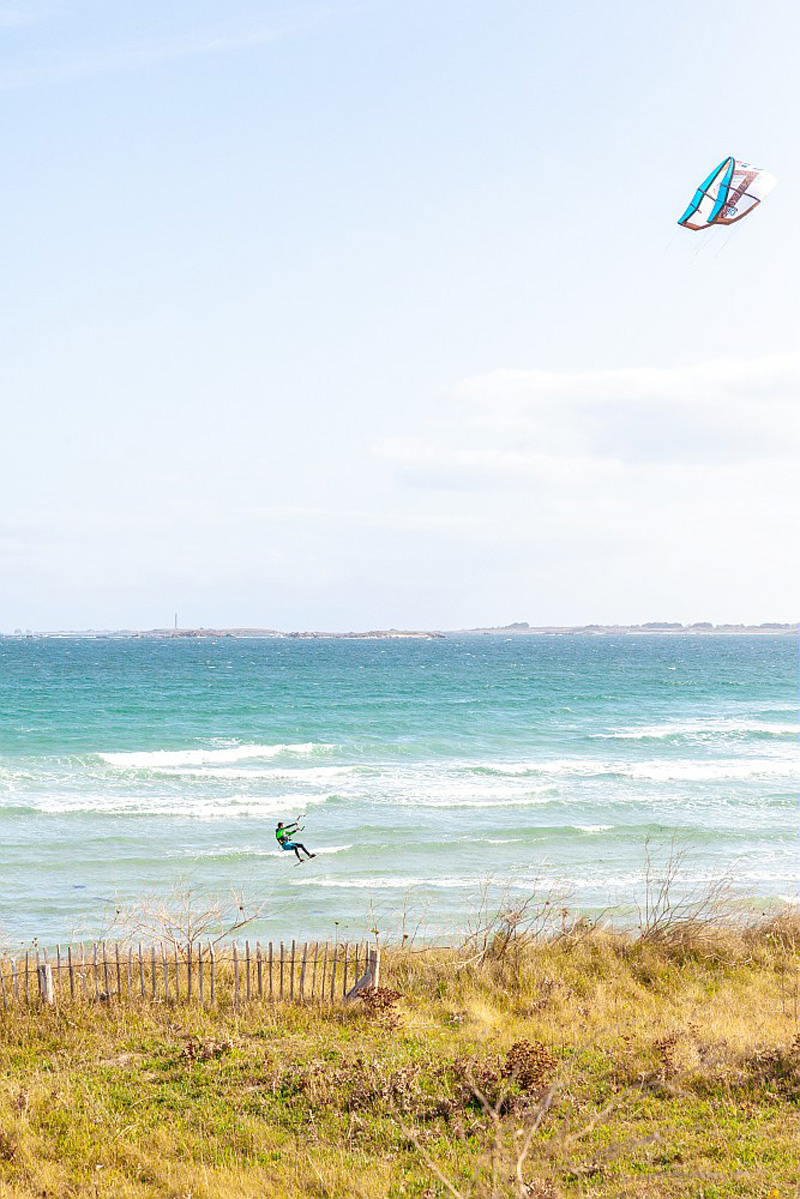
[{"left": 0, "top": 941, "right": 380, "bottom": 1010}]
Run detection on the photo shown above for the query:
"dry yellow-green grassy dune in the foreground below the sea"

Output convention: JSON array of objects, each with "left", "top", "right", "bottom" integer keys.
[{"left": 0, "top": 917, "right": 800, "bottom": 1199}]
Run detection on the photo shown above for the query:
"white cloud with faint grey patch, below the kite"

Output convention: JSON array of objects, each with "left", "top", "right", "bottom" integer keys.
[{"left": 375, "top": 355, "right": 800, "bottom": 489}]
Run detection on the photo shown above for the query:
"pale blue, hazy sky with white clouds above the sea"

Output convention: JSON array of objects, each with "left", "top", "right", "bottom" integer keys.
[{"left": 0, "top": 0, "right": 800, "bottom": 632}]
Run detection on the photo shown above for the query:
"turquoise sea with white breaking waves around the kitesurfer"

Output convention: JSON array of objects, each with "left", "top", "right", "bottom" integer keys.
[{"left": 0, "top": 635, "right": 798, "bottom": 942}]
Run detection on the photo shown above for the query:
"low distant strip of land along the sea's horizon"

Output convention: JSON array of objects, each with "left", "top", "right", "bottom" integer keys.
[{"left": 0, "top": 621, "right": 800, "bottom": 641}]
